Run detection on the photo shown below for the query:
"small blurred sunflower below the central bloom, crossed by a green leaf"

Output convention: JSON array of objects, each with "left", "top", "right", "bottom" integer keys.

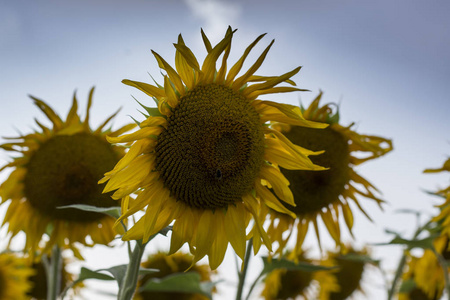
[{"left": 134, "top": 252, "right": 212, "bottom": 300}]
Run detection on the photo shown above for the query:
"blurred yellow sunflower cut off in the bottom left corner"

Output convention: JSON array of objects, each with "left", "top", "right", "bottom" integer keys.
[{"left": 0, "top": 252, "right": 33, "bottom": 300}]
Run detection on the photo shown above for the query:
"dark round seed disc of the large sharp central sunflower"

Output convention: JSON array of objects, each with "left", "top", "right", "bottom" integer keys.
[{"left": 155, "top": 84, "right": 265, "bottom": 209}]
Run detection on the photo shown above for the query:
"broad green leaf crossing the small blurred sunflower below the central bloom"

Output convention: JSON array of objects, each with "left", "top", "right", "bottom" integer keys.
[{"left": 140, "top": 272, "right": 212, "bottom": 299}]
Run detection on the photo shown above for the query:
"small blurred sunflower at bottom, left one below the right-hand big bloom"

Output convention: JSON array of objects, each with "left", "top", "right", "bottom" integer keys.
[{"left": 261, "top": 252, "right": 339, "bottom": 300}]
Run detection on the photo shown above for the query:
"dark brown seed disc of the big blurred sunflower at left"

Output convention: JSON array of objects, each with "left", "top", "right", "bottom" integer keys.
[{"left": 24, "top": 133, "right": 118, "bottom": 222}]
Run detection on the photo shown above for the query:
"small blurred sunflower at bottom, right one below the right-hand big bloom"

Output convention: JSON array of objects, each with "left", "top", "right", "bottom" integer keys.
[{"left": 321, "top": 246, "right": 373, "bottom": 300}]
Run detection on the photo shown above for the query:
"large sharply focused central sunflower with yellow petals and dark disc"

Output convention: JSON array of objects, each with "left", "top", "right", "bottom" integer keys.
[{"left": 101, "top": 28, "right": 326, "bottom": 269}]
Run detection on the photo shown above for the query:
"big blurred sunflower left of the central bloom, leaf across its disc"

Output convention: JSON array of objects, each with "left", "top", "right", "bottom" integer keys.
[{"left": 0, "top": 88, "right": 135, "bottom": 257}]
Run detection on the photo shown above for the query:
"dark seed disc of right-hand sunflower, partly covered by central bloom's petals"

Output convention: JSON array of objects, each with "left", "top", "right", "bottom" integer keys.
[{"left": 281, "top": 126, "right": 350, "bottom": 215}]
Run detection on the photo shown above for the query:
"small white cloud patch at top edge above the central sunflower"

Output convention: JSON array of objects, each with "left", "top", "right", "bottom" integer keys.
[{"left": 185, "top": 0, "right": 241, "bottom": 42}]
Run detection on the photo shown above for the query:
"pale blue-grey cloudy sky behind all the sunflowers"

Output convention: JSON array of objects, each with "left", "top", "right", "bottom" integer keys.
[{"left": 0, "top": 0, "right": 450, "bottom": 299}]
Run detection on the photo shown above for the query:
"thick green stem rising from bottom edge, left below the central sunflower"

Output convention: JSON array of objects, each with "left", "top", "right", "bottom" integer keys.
[{"left": 117, "top": 240, "right": 146, "bottom": 300}]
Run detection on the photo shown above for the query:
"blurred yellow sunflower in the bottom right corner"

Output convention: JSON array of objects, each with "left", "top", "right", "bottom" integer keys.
[{"left": 398, "top": 250, "right": 448, "bottom": 300}]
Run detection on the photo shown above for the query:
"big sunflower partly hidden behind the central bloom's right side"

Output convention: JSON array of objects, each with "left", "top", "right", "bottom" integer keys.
[{"left": 268, "top": 92, "right": 392, "bottom": 254}]
